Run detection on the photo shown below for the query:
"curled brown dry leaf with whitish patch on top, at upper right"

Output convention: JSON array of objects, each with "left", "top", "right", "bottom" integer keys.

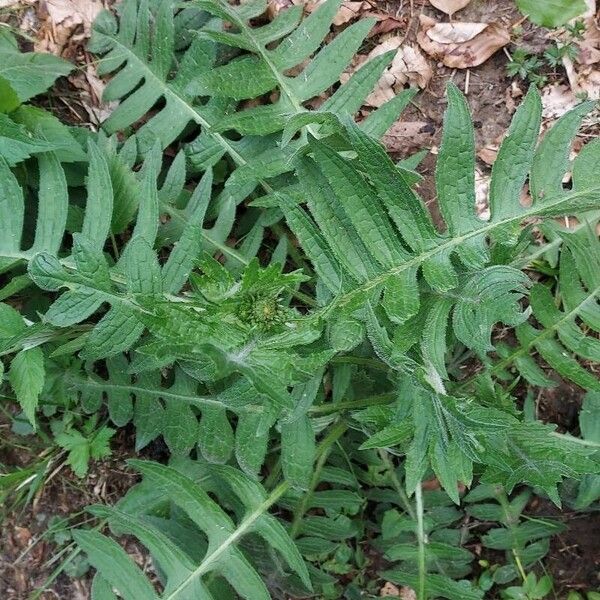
[{"left": 417, "top": 15, "right": 510, "bottom": 69}]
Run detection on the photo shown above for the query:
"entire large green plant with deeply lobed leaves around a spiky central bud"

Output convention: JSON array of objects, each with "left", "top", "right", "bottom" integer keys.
[{"left": 0, "top": 11, "right": 600, "bottom": 600}]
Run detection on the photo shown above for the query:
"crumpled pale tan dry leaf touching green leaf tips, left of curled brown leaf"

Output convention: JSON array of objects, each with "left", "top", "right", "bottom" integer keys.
[{"left": 352, "top": 36, "right": 433, "bottom": 107}]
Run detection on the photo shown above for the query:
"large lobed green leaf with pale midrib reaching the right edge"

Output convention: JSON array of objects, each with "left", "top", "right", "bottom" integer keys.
[{"left": 280, "top": 85, "right": 600, "bottom": 376}]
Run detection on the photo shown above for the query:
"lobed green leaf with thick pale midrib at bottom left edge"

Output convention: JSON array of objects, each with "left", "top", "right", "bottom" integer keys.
[{"left": 75, "top": 461, "right": 310, "bottom": 600}]
